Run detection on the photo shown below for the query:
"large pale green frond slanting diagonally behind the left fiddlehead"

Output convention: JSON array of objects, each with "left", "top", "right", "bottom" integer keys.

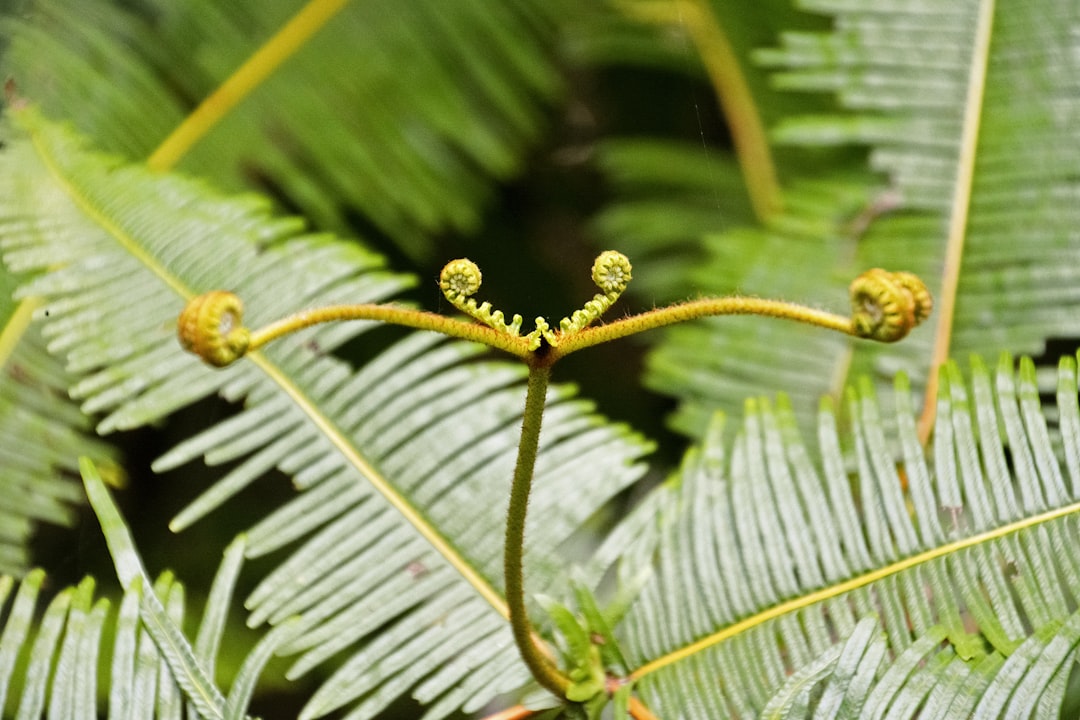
[{"left": 0, "top": 116, "right": 649, "bottom": 718}]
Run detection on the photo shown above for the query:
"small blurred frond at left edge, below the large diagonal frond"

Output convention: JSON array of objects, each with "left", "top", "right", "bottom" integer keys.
[{"left": 0, "top": 268, "right": 119, "bottom": 576}]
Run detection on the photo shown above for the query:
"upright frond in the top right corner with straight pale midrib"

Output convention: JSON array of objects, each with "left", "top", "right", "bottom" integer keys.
[{"left": 768, "top": 1, "right": 1080, "bottom": 405}]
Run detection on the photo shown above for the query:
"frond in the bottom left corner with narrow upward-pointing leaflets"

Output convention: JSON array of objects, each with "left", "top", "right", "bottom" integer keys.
[{"left": 0, "top": 461, "right": 265, "bottom": 720}]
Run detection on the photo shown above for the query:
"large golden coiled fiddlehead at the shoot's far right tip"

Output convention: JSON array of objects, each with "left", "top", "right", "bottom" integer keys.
[{"left": 850, "top": 268, "right": 933, "bottom": 342}]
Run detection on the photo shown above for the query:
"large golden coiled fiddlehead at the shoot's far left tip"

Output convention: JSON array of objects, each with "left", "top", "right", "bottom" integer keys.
[{"left": 177, "top": 290, "right": 251, "bottom": 367}]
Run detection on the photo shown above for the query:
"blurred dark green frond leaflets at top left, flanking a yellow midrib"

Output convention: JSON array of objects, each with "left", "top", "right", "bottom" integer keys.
[{"left": 0, "top": 0, "right": 559, "bottom": 259}]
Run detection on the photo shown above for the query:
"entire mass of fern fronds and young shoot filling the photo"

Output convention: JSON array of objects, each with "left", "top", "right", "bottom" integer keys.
[{"left": 0, "top": 0, "right": 1080, "bottom": 720}]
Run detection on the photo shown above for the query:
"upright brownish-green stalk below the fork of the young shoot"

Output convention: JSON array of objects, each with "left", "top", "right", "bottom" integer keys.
[{"left": 503, "top": 363, "right": 570, "bottom": 697}]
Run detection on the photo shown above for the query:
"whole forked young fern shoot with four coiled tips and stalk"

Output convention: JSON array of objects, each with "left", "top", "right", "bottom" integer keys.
[{"left": 178, "top": 250, "right": 933, "bottom": 698}]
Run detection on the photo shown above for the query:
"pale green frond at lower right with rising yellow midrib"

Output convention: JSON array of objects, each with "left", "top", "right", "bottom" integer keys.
[{"left": 597, "top": 358, "right": 1080, "bottom": 720}]
